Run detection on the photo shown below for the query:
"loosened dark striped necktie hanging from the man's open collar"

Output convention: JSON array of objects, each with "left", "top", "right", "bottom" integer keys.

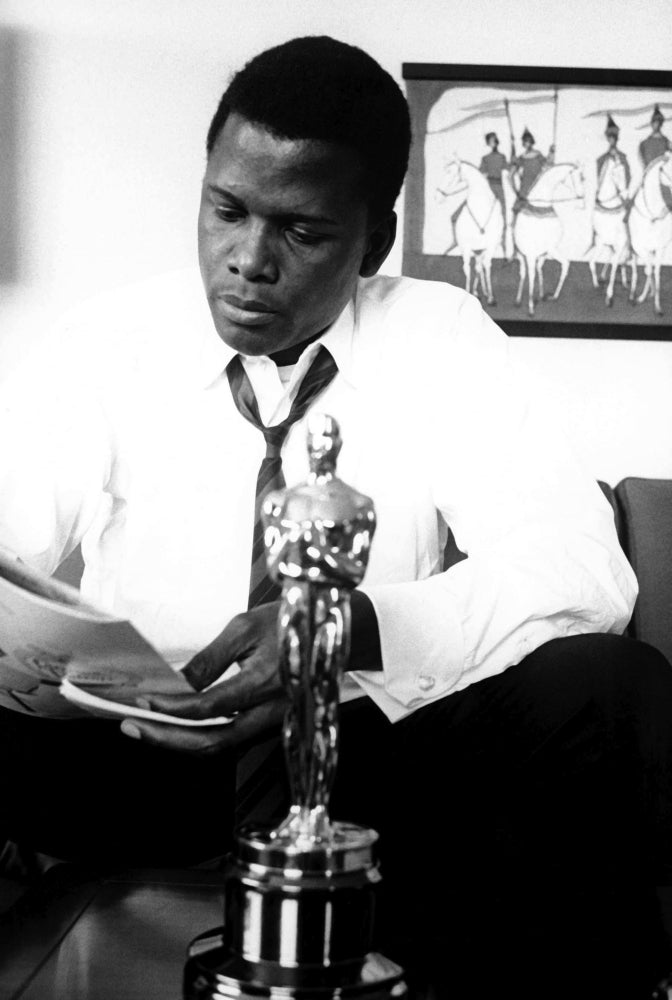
[{"left": 226, "top": 345, "right": 338, "bottom": 826}]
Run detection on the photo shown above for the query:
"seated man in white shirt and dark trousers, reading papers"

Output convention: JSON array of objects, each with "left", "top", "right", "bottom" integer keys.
[{"left": 0, "top": 38, "right": 672, "bottom": 1000}]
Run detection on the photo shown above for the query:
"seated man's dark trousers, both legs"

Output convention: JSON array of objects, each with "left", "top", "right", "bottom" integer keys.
[{"left": 0, "top": 635, "right": 672, "bottom": 1000}]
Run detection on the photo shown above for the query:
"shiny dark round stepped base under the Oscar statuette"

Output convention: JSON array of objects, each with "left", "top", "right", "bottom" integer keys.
[{"left": 183, "top": 823, "right": 407, "bottom": 1000}]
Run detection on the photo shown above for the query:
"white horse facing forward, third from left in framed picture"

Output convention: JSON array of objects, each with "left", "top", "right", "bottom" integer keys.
[{"left": 586, "top": 156, "right": 635, "bottom": 306}]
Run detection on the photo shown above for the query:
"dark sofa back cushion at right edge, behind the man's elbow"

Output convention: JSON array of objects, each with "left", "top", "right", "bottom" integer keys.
[{"left": 616, "top": 477, "right": 672, "bottom": 661}]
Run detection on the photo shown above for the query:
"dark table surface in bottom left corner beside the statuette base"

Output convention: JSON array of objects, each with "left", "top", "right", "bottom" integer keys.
[{"left": 0, "top": 866, "right": 223, "bottom": 1000}]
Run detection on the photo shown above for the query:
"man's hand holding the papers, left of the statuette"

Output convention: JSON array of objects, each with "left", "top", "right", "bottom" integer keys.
[{"left": 122, "top": 601, "right": 287, "bottom": 754}]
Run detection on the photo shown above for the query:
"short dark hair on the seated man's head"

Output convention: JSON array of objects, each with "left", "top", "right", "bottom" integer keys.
[{"left": 206, "top": 35, "right": 411, "bottom": 217}]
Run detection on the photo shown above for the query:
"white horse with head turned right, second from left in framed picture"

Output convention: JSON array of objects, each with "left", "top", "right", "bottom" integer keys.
[{"left": 502, "top": 163, "right": 585, "bottom": 316}]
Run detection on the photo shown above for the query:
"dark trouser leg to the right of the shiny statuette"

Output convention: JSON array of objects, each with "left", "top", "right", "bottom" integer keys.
[{"left": 332, "top": 635, "right": 672, "bottom": 1000}]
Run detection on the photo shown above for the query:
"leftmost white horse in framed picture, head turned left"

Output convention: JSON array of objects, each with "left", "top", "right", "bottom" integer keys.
[{"left": 437, "top": 158, "right": 504, "bottom": 305}]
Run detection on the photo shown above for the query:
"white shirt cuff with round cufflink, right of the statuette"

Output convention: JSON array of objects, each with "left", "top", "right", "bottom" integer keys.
[{"left": 350, "top": 576, "right": 465, "bottom": 722}]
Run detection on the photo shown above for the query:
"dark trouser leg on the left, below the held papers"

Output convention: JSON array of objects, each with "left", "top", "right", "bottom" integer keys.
[{"left": 0, "top": 710, "right": 235, "bottom": 868}]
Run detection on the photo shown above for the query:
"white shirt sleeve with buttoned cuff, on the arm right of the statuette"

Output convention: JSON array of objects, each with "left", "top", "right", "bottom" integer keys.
[{"left": 355, "top": 297, "right": 637, "bottom": 721}]
